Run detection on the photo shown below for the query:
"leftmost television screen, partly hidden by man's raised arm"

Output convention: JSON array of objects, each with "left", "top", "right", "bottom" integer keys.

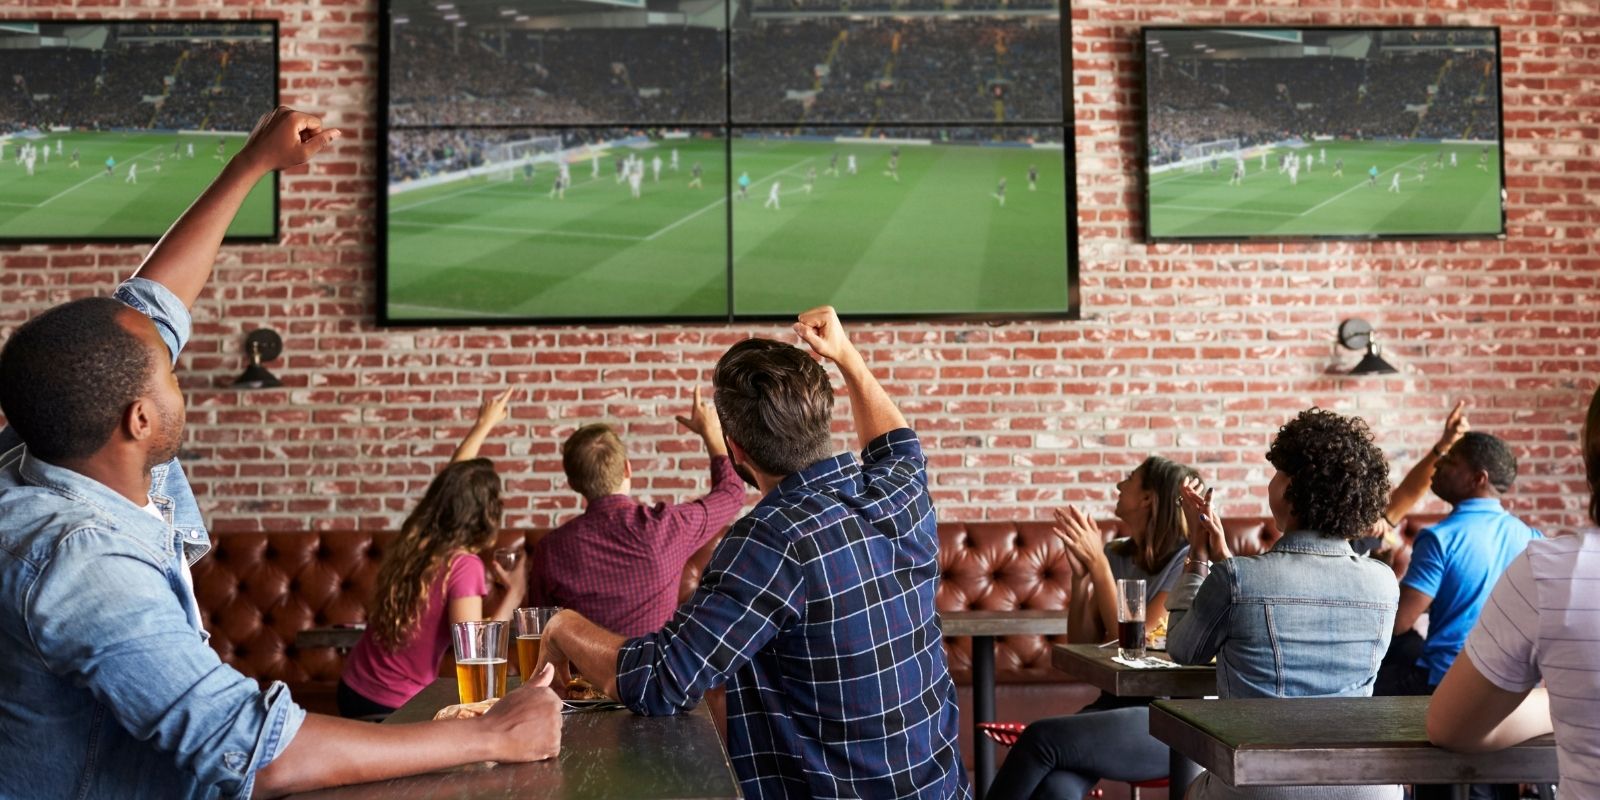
[{"left": 0, "top": 19, "right": 278, "bottom": 242}]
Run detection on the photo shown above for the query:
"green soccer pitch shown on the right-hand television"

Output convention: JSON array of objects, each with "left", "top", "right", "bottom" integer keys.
[{"left": 1149, "top": 141, "right": 1502, "bottom": 238}]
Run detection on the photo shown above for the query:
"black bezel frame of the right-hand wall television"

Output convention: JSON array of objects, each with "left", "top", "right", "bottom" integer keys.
[{"left": 1138, "top": 24, "right": 1509, "bottom": 245}]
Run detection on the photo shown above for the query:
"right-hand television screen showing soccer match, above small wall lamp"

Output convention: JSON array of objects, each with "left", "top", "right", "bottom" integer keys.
[{"left": 1144, "top": 27, "right": 1506, "bottom": 242}]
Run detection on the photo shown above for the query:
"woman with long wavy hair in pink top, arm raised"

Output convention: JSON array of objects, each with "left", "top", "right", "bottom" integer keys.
[{"left": 338, "top": 389, "right": 528, "bottom": 718}]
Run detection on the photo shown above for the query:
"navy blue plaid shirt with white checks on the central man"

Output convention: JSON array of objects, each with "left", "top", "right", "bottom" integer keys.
[{"left": 618, "top": 429, "right": 968, "bottom": 800}]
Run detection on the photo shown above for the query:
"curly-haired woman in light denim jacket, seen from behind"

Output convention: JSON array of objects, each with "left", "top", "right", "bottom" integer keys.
[{"left": 1166, "top": 408, "right": 1400, "bottom": 800}]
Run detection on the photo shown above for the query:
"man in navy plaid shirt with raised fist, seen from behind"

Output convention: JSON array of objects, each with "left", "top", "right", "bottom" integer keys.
[{"left": 541, "top": 307, "right": 970, "bottom": 800}]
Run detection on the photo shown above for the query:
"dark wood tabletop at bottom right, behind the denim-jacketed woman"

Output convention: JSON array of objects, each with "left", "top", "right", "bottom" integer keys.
[{"left": 1150, "top": 698, "right": 1557, "bottom": 786}]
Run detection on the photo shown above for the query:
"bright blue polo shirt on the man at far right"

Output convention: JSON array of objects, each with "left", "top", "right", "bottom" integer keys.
[{"left": 1400, "top": 498, "right": 1539, "bottom": 686}]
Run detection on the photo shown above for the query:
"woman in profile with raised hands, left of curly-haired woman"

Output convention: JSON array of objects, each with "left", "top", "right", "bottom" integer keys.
[{"left": 989, "top": 456, "right": 1198, "bottom": 800}]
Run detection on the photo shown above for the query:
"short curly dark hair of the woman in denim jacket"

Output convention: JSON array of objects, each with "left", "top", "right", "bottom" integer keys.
[{"left": 1267, "top": 408, "right": 1389, "bottom": 539}]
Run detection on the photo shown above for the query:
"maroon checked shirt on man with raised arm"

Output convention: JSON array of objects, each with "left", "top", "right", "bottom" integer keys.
[{"left": 528, "top": 456, "right": 744, "bottom": 637}]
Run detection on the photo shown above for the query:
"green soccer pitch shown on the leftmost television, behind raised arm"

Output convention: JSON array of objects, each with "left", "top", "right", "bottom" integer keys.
[{"left": 0, "top": 133, "right": 275, "bottom": 240}]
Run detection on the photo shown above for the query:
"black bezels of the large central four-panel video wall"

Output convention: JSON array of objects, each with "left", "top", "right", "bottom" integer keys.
[{"left": 373, "top": 0, "right": 1082, "bottom": 328}]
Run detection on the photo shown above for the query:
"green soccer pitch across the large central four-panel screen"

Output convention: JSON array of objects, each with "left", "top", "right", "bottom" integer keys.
[{"left": 386, "top": 130, "right": 1067, "bottom": 322}]
